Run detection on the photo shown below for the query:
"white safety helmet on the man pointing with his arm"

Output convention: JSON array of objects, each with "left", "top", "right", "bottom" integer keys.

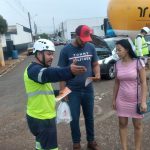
[{"left": 33, "top": 39, "right": 55, "bottom": 53}]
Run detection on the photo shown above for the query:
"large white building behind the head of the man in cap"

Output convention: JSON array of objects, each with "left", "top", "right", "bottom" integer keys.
[{"left": 62, "top": 17, "right": 104, "bottom": 40}]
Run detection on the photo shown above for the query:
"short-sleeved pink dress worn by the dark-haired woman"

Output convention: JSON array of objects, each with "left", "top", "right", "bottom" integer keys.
[{"left": 116, "top": 59, "right": 145, "bottom": 118}]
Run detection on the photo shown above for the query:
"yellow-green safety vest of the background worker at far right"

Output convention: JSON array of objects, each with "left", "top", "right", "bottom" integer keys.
[{"left": 135, "top": 36, "right": 149, "bottom": 56}]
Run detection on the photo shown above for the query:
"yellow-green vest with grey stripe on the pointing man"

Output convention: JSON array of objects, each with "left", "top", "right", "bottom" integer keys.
[{"left": 24, "top": 69, "right": 56, "bottom": 119}]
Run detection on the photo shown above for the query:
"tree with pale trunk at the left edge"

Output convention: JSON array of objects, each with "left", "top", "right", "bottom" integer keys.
[{"left": 0, "top": 15, "right": 8, "bottom": 66}]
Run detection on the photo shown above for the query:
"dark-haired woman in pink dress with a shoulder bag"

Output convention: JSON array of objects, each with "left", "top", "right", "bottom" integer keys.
[{"left": 112, "top": 39, "right": 147, "bottom": 150}]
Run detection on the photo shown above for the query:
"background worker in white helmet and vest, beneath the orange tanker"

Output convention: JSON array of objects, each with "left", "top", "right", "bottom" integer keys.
[{"left": 135, "top": 27, "right": 150, "bottom": 57}]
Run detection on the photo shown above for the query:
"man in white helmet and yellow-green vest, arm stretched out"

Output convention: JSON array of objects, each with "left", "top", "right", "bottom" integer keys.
[{"left": 24, "top": 39, "right": 86, "bottom": 150}]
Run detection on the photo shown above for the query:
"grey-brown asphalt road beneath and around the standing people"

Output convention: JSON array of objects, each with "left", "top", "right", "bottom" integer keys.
[{"left": 0, "top": 47, "right": 150, "bottom": 150}]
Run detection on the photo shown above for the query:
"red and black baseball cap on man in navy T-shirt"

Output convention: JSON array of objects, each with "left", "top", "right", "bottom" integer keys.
[{"left": 75, "top": 25, "right": 92, "bottom": 42}]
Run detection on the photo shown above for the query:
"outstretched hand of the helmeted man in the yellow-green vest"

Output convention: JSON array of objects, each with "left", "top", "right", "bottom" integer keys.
[{"left": 70, "top": 60, "right": 87, "bottom": 75}]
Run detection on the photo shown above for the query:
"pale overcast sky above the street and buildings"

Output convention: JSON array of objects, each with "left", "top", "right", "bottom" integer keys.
[{"left": 0, "top": 0, "right": 109, "bottom": 33}]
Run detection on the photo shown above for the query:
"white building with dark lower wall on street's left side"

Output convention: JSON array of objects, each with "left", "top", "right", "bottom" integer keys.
[{"left": 2, "top": 23, "right": 32, "bottom": 59}]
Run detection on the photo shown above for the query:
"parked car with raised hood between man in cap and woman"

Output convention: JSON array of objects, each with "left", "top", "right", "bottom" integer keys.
[{"left": 92, "top": 35, "right": 135, "bottom": 79}]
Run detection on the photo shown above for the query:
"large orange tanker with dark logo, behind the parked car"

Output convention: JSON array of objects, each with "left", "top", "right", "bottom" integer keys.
[{"left": 107, "top": 0, "right": 150, "bottom": 39}]
